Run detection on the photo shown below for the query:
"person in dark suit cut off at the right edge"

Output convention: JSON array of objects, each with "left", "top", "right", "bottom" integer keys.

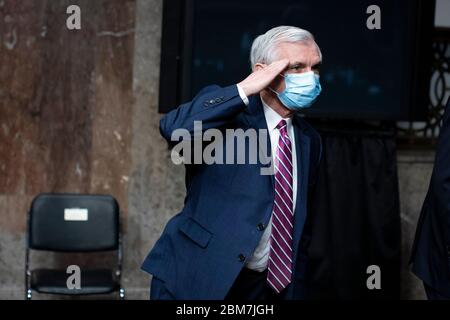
[{"left": 411, "top": 99, "right": 450, "bottom": 300}]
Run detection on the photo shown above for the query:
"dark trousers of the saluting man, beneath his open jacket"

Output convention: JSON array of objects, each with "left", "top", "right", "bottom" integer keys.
[{"left": 225, "top": 267, "right": 285, "bottom": 301}]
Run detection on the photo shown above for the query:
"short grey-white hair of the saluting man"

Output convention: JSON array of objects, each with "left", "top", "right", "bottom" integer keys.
[{"left": 250, "top": 26, "right": 322, "bottom": 68}]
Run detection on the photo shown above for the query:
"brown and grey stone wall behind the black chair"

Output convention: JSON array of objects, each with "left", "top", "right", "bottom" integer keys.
[{"left": 0, "top": 0, "right": 184, "bottom": 299}]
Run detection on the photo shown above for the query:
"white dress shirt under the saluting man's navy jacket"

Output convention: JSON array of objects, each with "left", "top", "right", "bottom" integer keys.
[{"left": 237, "top": 85, "right": 297, "bottom": 272}]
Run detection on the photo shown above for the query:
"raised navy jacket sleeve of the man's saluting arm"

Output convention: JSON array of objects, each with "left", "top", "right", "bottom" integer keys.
[{"left": 160, "top": 85, "right": 246, "bottom": 143}]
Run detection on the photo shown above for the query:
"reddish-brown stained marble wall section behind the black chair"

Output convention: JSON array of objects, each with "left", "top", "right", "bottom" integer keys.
[{"left": 0, "top": 0, "right": 137, "bottom": 298}]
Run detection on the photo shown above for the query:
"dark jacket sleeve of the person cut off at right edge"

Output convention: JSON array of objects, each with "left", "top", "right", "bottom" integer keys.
[{"left": 431, "top": 99, "right": 450, "bottom": 246}]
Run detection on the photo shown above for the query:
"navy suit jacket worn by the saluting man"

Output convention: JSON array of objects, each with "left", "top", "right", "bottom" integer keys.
[{"left": 142, "top": 85, "right": 322, "bottom": 299}]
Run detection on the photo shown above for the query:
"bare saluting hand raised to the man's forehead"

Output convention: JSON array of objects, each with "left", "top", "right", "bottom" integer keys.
[{"left": 238, "top": 59, "right": 289, "bottom": 97}]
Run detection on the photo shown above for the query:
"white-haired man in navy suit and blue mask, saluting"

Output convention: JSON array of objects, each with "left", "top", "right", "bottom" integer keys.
[{"left": 142, "top": 26, "right": 322, "bottom": 300}]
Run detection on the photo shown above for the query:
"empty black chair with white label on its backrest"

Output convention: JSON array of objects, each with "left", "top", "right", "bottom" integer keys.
[{"left": 25, "top": 194, "right": 125, "bottom": 300}]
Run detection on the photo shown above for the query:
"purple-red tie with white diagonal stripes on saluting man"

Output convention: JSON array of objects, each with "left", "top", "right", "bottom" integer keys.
[{"left": 267, "top": 120, "right": 294, "bottom": 293}]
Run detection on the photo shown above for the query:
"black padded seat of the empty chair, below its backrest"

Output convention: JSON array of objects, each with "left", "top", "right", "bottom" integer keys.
[{"left": 30, "top": 269, "right": 120, "bottom": 295}]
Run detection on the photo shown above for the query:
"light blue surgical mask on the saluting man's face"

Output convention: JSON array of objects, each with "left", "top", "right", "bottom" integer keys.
[{"left": 270, "top": 71, "right": 322, "bottom": 111}]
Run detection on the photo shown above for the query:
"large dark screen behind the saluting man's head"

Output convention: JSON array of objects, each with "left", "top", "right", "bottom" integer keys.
[{"left": 160, "top": 0, "right": 434, "bottom": 120}]
